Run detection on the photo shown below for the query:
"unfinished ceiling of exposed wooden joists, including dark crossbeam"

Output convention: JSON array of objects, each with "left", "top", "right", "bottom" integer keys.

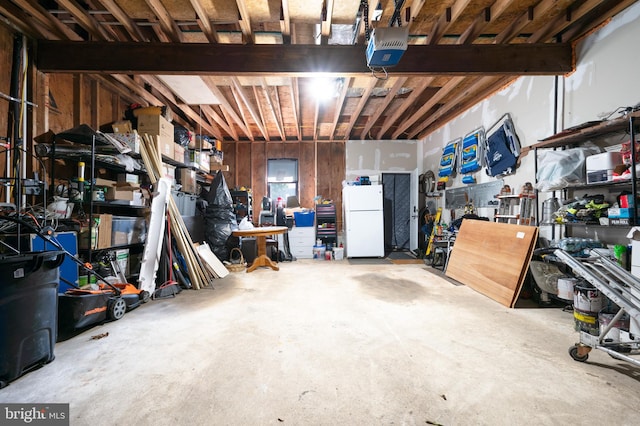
[{"left": 0, "top": 0, "right": 635, "bottom": 141}]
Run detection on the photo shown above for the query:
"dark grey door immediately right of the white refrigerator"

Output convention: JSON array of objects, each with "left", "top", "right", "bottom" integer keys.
[{"left": 382, "top": 173, "right": 411, "bottom": 252}]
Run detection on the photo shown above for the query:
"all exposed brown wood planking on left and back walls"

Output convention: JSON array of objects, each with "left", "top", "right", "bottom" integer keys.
[{"left": 0, "top": 25, "right": 345, "bottom": 235}]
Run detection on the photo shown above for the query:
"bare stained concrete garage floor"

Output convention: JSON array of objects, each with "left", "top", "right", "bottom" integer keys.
[{"left": 0, "top": 260, "right": 640, "bottom": 425}]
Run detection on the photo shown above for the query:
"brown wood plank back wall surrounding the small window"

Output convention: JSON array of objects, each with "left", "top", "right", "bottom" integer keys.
[{"left": 222, "top": 141, "right": 345, "bottom": 231}]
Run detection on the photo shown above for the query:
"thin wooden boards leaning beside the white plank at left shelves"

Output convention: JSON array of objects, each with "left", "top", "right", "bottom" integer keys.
[{"left": 140, "top": 134, "right": 229, "bottom": 290}]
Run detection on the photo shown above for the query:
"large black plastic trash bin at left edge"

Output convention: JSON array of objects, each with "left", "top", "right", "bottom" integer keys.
[{"left": 0, "top": 251, "right": 64, "bottom": 388}]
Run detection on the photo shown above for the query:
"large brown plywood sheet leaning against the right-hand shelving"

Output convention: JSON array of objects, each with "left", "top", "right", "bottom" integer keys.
[{"left": 446, "top": 219, "right": 538, "bottom": 308}]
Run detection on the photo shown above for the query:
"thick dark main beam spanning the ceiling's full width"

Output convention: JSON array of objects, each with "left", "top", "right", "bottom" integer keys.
[{"left": 36, "top": 40, "right": 573, "bottom": 76}]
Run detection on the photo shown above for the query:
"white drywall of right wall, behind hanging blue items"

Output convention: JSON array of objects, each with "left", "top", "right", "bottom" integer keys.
[{"left": 420, "top": 3, "right": 640, "bottom": 231}]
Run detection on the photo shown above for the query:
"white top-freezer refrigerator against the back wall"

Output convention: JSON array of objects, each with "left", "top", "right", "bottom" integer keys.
[{"left": 342, "top": 185, "right": 384, "bottom": 257}]
